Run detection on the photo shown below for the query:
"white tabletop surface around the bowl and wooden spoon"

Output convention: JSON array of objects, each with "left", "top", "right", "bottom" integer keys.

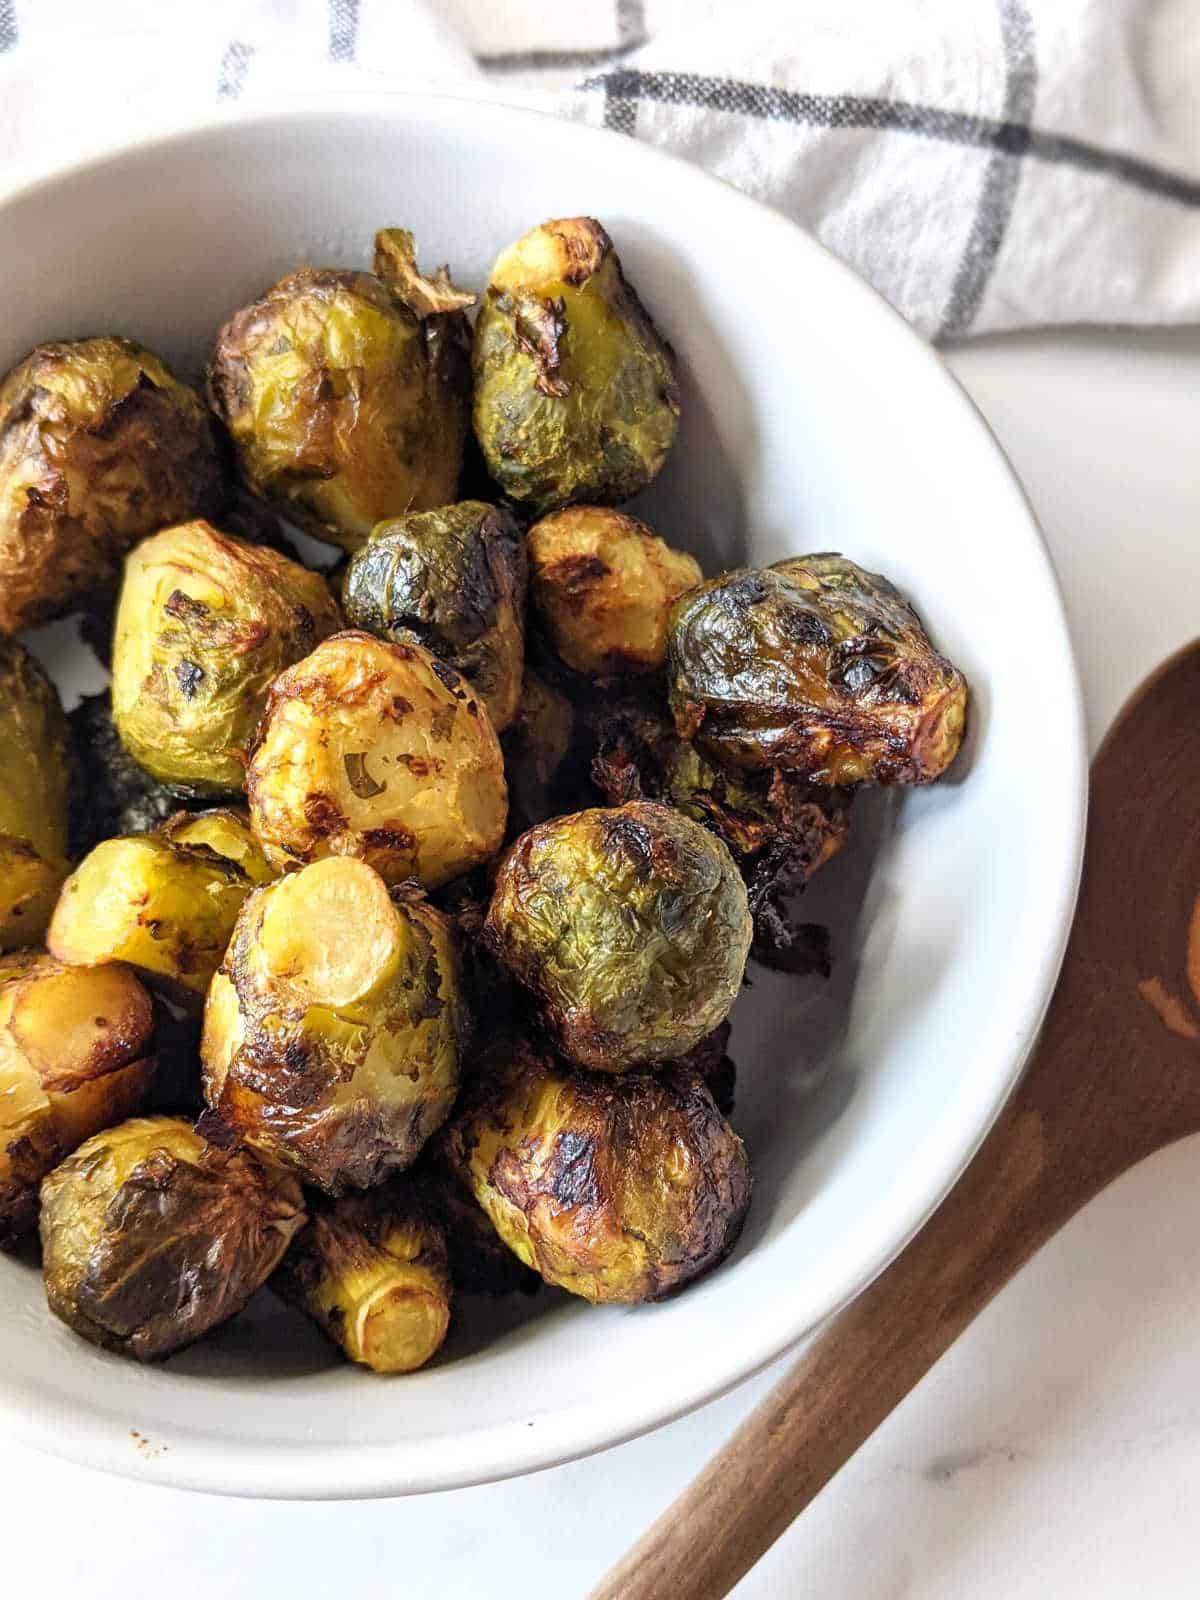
[{"left": 0, "top": 321, "right": 1200, "bottom": 1600}]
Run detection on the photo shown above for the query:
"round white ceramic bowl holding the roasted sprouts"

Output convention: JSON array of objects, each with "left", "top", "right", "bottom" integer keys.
[{"left": 0, "top": 96, "right": 1085, "bottom": 1498}]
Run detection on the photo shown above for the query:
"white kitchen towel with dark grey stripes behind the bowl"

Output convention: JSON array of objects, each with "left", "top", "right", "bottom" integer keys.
[{"left": 0, "top": 0, "right": 1200, "bottom": 336}]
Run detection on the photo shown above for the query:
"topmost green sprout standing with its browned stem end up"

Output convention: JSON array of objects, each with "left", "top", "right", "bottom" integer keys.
[{"left": 472, "top": 216, "right": 678, "bottom": 514}]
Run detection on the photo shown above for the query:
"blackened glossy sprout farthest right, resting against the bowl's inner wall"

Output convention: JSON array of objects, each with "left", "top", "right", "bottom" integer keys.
[{"left": 667, "top": 555, "right": 966, "bottom": 784}]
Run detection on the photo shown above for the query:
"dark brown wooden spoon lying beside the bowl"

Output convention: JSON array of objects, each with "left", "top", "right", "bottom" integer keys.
[{"left": 592, "top": 642, "right": 1200, "bottom": 1600}]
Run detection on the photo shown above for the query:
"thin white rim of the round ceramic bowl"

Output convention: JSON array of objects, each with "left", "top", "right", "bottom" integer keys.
[{"left": 0, "top": 88, "right": 1088, "bottom": 1499}]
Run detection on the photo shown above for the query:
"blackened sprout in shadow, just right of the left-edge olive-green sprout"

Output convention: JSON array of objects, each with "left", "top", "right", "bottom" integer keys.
[{"left": 67, "top": 690, "right": 192, "bottom": 861}]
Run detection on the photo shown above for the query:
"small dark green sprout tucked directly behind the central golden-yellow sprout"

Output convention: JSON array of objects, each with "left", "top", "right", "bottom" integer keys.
[{"left": 342, "top": 501, "right": 528, "bottom": 733}]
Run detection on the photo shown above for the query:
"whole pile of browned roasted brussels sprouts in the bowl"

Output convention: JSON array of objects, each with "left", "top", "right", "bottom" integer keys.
[{"left": 0, "top": 218, "right": 966, "bottom": 1371}]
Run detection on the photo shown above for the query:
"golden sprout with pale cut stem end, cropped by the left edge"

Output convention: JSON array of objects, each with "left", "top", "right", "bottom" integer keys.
[{"left": 0, "top": 950, "right": 154, "bottom": 1246}]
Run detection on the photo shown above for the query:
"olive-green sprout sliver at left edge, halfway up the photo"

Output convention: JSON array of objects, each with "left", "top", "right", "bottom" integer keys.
[{"left": 0, "top": 638, "right": 69, "bottom": 950}]
